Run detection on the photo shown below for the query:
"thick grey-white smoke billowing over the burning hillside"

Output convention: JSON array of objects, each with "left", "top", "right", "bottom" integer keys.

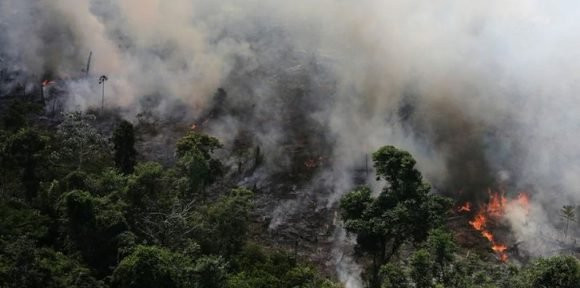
[{"left": 0, "top": 0, "right": 580, "bottom": 287}]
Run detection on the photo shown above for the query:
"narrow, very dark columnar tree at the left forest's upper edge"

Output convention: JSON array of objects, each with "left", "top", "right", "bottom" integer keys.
[{"left": 113, "top": 120, "right": 137, "bottom": 174}]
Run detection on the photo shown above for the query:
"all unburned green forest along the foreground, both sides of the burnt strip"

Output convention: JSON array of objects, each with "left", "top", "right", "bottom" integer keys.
[{"left": 0, "top": 94, "right": 580, "bottom": 288}]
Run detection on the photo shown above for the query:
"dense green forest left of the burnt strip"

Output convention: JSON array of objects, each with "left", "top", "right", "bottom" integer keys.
[{"left": 0, "top": 102, "right": 338, "bottom": 288}]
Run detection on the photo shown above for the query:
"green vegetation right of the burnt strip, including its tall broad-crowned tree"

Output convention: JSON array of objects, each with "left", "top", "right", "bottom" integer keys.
[{"left": 340, "top": 146, "right": 580, "bottom": 288}]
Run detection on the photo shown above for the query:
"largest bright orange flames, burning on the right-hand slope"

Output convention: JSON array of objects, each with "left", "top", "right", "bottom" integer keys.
[{"left": 458, "top": 190, "right": 530, "bottom": 262}]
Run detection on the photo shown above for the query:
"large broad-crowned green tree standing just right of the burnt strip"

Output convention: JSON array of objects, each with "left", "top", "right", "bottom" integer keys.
[{"left": 340, "top": 146, "right": 451, "bottom": 287}]
